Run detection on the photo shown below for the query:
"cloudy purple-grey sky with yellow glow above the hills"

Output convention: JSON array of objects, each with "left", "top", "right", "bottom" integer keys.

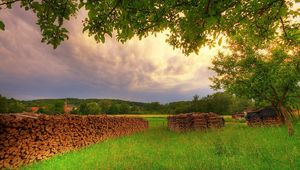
[{"left": 0, "top": 5, "right": 223, "bottom": 103}]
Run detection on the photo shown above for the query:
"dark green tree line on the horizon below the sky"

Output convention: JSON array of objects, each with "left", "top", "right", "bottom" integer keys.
[{"left": 0, "top": 92, "right": 256, "bottom": 115}]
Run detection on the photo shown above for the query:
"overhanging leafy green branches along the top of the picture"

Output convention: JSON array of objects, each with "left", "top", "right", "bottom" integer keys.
[{"left": 0, "top": 0, "right": 300, "bottom": 54}]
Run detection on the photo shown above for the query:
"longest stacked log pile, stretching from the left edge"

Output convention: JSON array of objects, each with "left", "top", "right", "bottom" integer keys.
[{"left": 0, "top": 114, "right": 148, "bottom": 169}]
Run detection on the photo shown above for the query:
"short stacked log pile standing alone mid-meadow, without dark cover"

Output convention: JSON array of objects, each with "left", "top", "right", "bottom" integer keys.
[{"left": 168, "top": 112, "right": 224, "bottom": 131}]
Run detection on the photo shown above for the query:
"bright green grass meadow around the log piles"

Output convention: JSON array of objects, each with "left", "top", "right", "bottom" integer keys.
[{"left": 23, "top": 118, "right": 300, "bottom": 170}]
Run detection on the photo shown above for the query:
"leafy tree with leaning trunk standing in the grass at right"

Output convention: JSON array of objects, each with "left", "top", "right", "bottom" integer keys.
[{"left": 211, "top": 38, "right": 300, "bottom": 134}]
